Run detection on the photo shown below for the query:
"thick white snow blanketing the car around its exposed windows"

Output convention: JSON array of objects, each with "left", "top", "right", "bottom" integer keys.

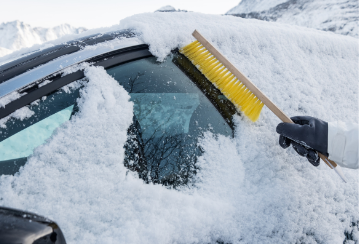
[{"left": 0, "top": 12, "right": 359, "bottom": 243}]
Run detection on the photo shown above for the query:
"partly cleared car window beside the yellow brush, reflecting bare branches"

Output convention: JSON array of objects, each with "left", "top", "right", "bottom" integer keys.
[{"left": 107, "top": 52, "right": 235, "bottom": 186}]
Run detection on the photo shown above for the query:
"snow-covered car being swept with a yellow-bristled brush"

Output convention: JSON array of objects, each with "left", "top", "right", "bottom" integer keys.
[{"left": 0, "top": 12, "right": 359, "bottom": 244}]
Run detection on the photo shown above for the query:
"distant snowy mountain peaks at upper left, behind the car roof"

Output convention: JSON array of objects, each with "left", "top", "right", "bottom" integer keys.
[{"left": 0, "top": 20, "right": 86, "bottom": 56}]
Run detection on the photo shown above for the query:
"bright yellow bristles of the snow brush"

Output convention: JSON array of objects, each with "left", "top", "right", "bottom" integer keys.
[{"left": 180, "top": 41, "right": 264, "bottom": 122}]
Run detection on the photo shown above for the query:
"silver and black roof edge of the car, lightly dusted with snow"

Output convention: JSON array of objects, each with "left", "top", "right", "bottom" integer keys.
[{"left": 0, "top": 30, "right": 143, "bottom": 98}]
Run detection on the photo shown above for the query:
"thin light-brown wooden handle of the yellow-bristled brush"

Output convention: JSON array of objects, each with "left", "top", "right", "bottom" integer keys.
[{"left": 192, "top": 30, "right": 337, "bottom": 168}]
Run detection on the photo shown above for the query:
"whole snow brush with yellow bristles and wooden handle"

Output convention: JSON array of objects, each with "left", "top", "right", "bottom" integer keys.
[{"left": 179, "top": 30, "right": 346, "bottom": 182}]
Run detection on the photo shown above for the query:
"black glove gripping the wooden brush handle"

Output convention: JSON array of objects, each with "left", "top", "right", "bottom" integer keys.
[{"left": 277, "top": 116, "right": 328, "bottom": 166}]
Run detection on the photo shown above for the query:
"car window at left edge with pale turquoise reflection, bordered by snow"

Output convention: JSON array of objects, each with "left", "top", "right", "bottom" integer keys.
[{"left": 0, "top": 88, "right": 79, "bottom": 175}]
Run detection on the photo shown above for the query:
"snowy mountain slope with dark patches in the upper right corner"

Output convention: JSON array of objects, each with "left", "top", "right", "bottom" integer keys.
[{"left": 227, "top": 0, "right": 359, "bottom": 37}]
